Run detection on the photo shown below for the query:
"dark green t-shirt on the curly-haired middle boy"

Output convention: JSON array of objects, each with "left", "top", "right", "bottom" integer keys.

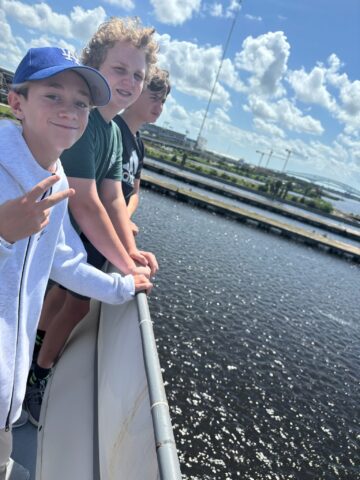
[{"left": 60, "top": 108, "right": 122, "bottom": 186}]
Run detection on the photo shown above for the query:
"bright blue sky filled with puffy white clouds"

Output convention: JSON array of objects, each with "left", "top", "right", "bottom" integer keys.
[{"left": 0, "top": 0, "right": 360, "bottom": 189}]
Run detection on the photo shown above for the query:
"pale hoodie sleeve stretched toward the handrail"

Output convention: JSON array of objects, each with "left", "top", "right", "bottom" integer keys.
[{"left": 50, "top": 209, "right": 135, "bottom": 304}]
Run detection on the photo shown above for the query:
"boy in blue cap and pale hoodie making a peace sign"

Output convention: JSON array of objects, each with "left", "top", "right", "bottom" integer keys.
[{"left": 0, "top": 47, "right": 151, "bottom": 480}]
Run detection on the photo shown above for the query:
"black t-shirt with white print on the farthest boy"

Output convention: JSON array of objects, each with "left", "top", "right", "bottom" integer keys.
[{"left": 113, "top": 115, "right": 145, "bottom": 204}]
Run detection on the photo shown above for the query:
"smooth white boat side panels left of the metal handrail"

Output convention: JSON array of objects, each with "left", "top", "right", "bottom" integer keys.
[{"left": 36, "top": 300, "right": 159, "bottom": 480}]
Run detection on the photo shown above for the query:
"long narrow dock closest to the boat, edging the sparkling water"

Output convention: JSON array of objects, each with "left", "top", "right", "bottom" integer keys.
[{"left": 141, "top": 173, "right": 360, "bottom": 263}]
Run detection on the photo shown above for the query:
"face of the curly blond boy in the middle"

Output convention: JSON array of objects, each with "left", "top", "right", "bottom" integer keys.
[{"left": 99, "top": 41, "right": 146, "bottom": 116}]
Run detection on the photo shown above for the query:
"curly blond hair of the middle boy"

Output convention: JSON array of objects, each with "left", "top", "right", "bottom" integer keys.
[{"left": 81, "top": 17, "right": 159, "bottom": 77}]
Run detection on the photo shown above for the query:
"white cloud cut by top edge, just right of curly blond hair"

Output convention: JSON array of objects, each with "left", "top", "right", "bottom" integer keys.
[{"left": 150, "top": 0, "right": 201, "bottom": 25}]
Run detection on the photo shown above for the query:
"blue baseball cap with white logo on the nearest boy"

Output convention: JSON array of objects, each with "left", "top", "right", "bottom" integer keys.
[{"left": 13, "top": 47, "right": 111, "bottom": 107}]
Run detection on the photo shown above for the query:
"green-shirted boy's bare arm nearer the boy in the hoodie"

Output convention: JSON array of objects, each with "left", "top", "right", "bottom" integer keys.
[{"left": 68, "top": 177, "right": 149, "bottom": 274}]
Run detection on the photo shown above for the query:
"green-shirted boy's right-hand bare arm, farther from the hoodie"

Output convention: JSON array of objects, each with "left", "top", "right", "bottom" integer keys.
[{"left": 99, "top": 178, "right": 159, "bottom": 275}]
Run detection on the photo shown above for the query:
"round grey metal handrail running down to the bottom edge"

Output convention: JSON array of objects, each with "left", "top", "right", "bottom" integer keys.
[{"left": 136, "top": 292, "right": 182, "bottom": 480}]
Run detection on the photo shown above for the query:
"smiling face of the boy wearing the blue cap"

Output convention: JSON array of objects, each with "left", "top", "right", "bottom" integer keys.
[{"left": 9, "top": 70, "right": 90, "bottom": 159}]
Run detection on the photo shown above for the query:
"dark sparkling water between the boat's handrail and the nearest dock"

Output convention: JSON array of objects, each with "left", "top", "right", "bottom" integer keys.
[{"left": 136, "top": 191, "right": 360, "bottom": 480}]
